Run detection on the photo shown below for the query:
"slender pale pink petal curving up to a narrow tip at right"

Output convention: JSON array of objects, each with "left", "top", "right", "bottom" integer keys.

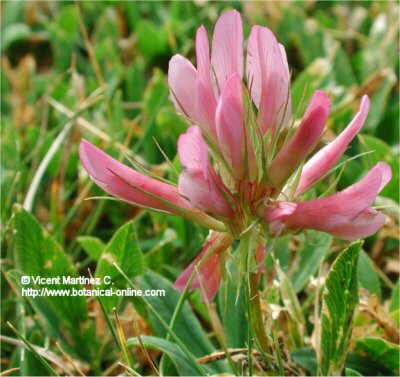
[{"left": 296, "top": 95, "right": 369, "bottom": 195}]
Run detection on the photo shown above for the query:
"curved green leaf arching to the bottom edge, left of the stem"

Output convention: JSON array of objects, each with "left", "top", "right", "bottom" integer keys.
[{"left": 127, "top": 336, "right": 203, "bottom": 376}]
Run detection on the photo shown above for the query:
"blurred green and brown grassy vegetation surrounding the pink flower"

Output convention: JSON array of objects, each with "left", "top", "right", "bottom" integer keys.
[{"left": 0, "top": 0, "right": 400, "bottom": 375}]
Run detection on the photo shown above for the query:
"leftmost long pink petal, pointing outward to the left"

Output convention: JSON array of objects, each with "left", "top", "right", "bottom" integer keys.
[{"left": 79, "top": 140, "right": 190, "bottom": 214}]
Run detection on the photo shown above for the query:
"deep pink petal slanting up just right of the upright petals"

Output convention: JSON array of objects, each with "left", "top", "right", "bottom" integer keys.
[{"left": 268, "top": 91, "right": 329, "bottom": 187}]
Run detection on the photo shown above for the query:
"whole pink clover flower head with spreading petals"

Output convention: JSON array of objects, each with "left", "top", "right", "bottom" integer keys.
[{"left": 80, "top": 11, "right": 391, "bottom": 299}]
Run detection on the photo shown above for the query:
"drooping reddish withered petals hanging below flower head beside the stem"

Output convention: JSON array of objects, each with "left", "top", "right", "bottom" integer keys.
[{"left": 174, "top": 232, "right": 232, "bottom": 301}]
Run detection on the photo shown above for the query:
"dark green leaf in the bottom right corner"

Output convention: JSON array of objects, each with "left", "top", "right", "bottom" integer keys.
[{"left": 355, "top": 337, "right": 400, "bottom": 376}]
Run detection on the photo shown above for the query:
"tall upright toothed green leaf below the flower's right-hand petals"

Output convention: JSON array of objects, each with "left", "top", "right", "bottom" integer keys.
[{"left": 318, "top": 241, "right": 362, "bottom": 376}]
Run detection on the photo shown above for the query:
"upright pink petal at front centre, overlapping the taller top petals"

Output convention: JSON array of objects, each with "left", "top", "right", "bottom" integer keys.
[{"left": 216, "top": 73, "right": 246, "bottom": 179}]
